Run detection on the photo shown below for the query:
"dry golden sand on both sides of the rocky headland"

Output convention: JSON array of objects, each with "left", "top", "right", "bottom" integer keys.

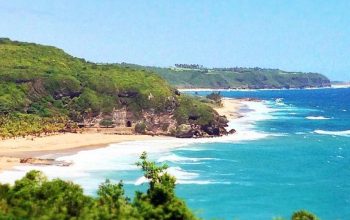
[{"left": 0, "top": 99, "right": 241, "bottom": 172}]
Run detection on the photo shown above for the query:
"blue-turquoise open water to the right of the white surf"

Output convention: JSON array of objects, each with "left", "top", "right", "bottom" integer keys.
[{"left": 174, "top": 89, "right": 350, "bottom": 219}]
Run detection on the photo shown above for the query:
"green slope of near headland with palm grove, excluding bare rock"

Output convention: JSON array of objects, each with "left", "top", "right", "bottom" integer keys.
[{"left": 0, "top": 39, "right": 219, "bottom": 137}]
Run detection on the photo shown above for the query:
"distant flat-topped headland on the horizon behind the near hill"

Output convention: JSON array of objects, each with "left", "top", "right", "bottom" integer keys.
[{"left": 121, "top": 63, "right": 330, "bottom": 89}]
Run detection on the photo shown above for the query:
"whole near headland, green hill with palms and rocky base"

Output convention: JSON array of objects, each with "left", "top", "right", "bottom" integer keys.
[{"left": 0, "top": 38, "right": 226, "bottom": 138}]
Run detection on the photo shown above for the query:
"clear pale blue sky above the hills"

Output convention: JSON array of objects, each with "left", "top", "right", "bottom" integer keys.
[{"left": 0, "top": 0, "right": 350, "bottom": 81}]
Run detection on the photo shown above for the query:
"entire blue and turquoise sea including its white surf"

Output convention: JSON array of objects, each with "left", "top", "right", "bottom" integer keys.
[{"left": 0, "top": 88, "right": 350, "bottom": 220}]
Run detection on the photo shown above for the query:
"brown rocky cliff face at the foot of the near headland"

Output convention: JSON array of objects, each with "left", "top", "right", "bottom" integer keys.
[{"left": 80, "top": 107, "right": 234, "bottom": 138}]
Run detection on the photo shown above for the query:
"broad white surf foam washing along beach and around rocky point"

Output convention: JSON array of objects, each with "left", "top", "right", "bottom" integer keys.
[{"left": 0, "top": 101, "right": 278, "bottom": 187}]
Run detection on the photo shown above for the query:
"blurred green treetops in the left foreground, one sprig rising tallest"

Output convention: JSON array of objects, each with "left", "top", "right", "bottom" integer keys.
[{"left": 0, "top": 153, "right": 196, "bottom": 220}]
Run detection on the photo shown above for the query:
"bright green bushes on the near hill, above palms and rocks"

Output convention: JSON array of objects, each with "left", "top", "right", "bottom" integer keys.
[{"left": 0, "top": 39, "right": 173, "bottom": 116}]
